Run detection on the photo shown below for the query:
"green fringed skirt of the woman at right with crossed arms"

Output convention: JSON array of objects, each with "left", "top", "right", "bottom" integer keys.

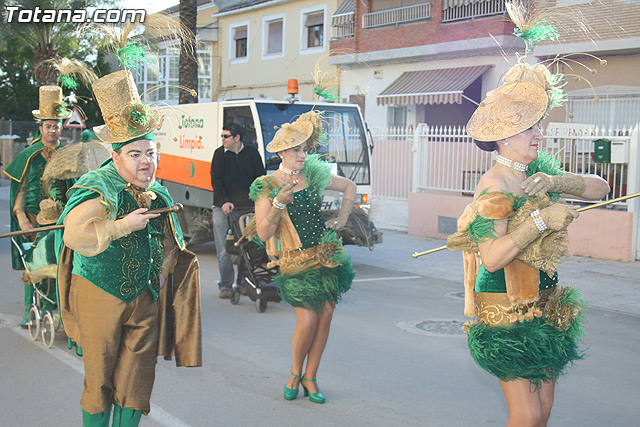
[{"left": 467, "top": 288, "right": 584, "bottom": 388}]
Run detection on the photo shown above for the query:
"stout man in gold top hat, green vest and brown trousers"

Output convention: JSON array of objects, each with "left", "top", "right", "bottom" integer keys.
[{"left": 56, "top": 70, "right": 201, "bottom": 426}]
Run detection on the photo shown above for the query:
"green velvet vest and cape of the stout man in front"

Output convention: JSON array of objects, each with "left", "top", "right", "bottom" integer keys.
[{"left": 56, "top": 160, "right": 184, "bottom": 302}]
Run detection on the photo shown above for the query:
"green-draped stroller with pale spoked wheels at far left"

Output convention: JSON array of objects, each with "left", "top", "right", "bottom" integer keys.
[{"left": 11, "top": 233, "right": 60, "bottom": 348}]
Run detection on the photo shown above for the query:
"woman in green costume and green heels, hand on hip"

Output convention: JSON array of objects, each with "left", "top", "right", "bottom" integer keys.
[{"left": 249, "top": 111, "right": 356, "bottom": 403}]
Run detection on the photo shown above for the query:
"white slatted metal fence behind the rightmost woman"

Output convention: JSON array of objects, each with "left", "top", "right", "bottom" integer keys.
[{"left": 371, "top": 124, "right": 639, "bottom": 208}]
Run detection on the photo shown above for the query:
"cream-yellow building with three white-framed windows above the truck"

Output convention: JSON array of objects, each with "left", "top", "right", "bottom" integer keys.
[{"left": 214, "top": 0, "right": 344, "bottom": 101}]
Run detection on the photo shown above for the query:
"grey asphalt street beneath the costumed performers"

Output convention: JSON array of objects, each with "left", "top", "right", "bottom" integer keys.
[{"left": 0, "top": 186, "right": 640, "bottom": 427}]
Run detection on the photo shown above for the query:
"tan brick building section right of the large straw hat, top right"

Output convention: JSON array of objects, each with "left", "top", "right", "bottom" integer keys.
[{"left": 533, "top": 0, "right": 640, "bottom": 131}]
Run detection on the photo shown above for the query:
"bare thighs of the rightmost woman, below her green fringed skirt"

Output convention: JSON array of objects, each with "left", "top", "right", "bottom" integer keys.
[{"left": 500, "top": 379, "right": 555, "bottom": 427}]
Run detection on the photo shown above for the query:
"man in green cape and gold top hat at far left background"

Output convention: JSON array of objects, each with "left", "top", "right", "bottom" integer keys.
[{"left": 4, "top": 86, "right": 71, "bottom": 328}]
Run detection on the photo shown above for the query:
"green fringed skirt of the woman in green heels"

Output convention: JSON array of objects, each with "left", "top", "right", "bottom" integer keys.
[{"left": 275, "top": 248, "right": 356, "bottom": 312}]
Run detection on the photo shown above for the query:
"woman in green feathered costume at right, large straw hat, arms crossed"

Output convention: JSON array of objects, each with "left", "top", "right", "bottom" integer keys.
[{"left": 448, "top": 63, "right": 609, "bottom": 427}]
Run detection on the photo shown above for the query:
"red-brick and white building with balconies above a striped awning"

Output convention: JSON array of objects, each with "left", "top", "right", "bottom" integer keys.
[{"left": 331, "top": 0, "right": 524, "bottom": 127}]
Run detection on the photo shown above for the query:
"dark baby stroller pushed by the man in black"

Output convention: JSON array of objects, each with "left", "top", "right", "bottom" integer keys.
[{"left": 226, "top": 209, "right": 280, "bottom": 313}]
